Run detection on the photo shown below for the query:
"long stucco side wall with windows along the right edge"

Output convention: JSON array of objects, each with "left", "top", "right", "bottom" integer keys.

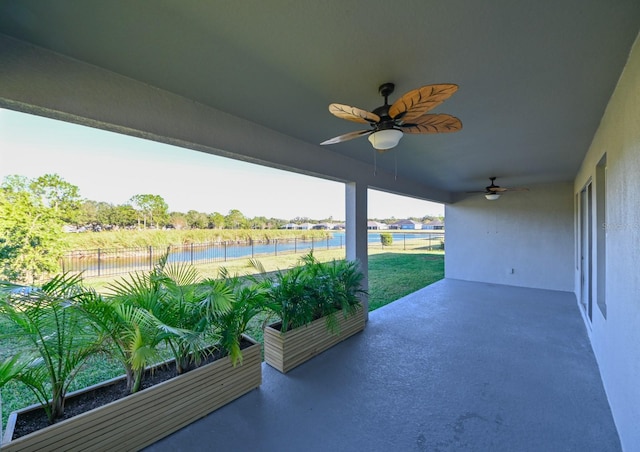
[{"left": 576, "top": 30, "right": 640, "bottom": 451}]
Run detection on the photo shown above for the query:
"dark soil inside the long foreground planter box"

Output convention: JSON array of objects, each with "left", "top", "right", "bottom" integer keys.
[{"left": 12, "top": 339, "right": 253, "bottom": 439}]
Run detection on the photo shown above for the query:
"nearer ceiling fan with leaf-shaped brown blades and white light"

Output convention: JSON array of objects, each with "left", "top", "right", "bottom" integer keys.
[{"left": 320, "top": 83, "right": 462, "bottom": 151}]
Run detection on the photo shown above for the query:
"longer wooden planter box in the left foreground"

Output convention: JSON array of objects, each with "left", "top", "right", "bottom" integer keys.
[{"left": 1, "top": 341, "right": 262, "bottom": 452}]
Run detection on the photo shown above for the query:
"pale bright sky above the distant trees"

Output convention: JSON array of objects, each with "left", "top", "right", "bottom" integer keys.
[{"left": 0, "top": 109, "right": 444, "bottom": 220}]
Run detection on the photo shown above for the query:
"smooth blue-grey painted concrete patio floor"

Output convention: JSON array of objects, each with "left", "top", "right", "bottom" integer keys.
[{"left": 147, "top": 280, "right": 621, "bottom": 452}]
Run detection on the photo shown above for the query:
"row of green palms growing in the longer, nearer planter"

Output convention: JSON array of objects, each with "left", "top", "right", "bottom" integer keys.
[{"left": 0, "top": 251, "right": 263, "bottom": 423}]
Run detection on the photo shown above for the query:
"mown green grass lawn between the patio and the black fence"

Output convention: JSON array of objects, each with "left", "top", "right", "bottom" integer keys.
[{"left": 0, "top": 244, "right": 444, "bottom": 425}]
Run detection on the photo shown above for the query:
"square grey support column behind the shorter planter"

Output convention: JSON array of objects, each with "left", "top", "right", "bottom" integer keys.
[{"left": 345, "top": 182, "right": 369, "bottom": 320}]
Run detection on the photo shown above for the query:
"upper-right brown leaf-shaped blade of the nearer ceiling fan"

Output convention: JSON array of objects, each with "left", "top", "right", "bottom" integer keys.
[{"left": 389, "top": 83, "right": 458, "bottom": 123}]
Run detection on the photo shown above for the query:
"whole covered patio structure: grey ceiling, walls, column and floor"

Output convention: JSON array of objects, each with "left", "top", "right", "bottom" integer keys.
[{"left": 0, "top": 0, "right": 640, "bottom": 451}]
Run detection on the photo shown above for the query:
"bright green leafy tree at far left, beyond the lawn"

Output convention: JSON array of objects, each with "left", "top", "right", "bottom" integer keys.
[{"left": 0, "top": 175, "right": 80, "bottom": 281}]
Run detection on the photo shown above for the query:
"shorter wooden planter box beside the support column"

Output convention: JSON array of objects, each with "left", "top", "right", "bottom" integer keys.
[{"left": 264, "top": 306, "right": 364, "bottom": 373}]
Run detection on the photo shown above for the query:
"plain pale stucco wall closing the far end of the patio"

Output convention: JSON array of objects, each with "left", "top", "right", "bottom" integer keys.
[{"left": 445, "top": 183, "right": 574, "bottom": 291}]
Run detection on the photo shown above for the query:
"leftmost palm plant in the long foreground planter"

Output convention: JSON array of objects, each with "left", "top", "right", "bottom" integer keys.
[{"left": 0, "top": 274, "right": 106, "bottom": 423}]
